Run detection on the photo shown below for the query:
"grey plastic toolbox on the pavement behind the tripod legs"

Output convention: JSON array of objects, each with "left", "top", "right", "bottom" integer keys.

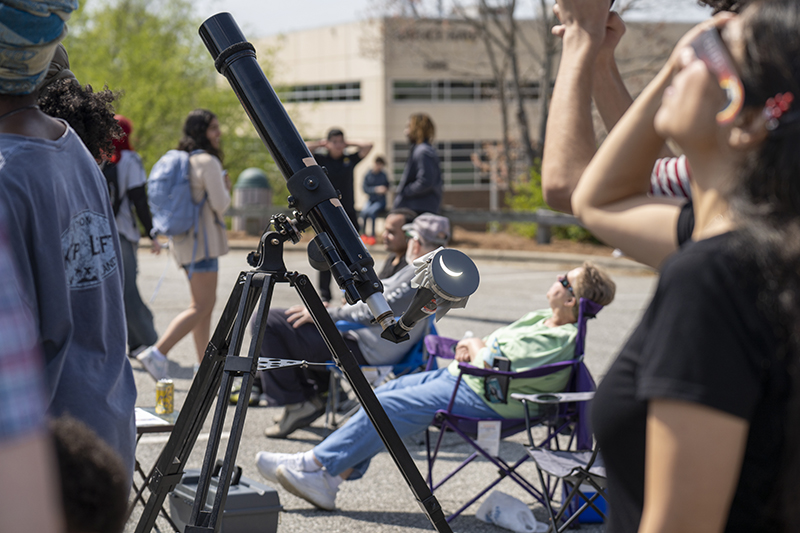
[{"left": 169, "top": 469, "right": 283, "bottom": 533}]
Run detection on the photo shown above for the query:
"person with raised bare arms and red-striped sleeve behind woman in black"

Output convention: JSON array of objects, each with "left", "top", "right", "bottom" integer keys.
[{"left": 542, "top": 0, "right": 750, "bottom": 222}]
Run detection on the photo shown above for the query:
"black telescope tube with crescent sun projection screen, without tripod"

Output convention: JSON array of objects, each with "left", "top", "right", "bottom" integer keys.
[{"left": 200, "top": 13, "right": 480, "bottom": 343}]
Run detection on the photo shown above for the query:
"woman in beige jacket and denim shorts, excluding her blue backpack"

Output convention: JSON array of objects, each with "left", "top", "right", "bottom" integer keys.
[{"left": 136, "top": 109, "right": 231, "bottom": 380}]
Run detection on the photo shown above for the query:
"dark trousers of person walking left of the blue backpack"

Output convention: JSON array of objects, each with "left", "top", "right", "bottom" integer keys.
[{"left": 119, "top": 235, "right": 158, "bottom": 351}]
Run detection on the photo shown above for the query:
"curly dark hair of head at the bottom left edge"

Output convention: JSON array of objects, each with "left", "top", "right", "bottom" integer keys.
[{"left": 50, "top": 415, "right": 130, "bottom": 533}]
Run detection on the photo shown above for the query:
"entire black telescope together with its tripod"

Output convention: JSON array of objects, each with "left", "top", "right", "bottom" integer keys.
[{"left": 134, "top": 13, "right": 479, "bottom": 533}]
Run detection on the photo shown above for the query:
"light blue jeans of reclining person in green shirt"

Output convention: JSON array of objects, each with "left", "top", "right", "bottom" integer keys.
[{"left": 314, "top": 368, "right": 497, "bottom": 479}]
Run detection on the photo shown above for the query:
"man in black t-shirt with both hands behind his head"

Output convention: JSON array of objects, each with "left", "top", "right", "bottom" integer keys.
[{"left": 306, "top": 128, "right": 372, "bottom": 302}]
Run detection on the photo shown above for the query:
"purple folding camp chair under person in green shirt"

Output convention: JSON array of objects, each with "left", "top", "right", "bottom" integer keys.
[{"left": 425, "top": 298, "right": 603, "bottom": 522}]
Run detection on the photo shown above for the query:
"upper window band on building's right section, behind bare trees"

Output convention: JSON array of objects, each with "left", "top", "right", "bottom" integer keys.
[{"left": 392, "top": 80, "right": 539, "bottom": 102}]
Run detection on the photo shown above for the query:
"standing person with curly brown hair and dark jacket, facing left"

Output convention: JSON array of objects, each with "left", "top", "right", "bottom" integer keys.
[{"left": 394, "top": 113, "right": 443, "bottom": 214}]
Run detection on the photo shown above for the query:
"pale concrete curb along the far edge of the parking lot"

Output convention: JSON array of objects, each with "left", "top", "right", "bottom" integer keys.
[{"left": 220, "top": 237, "right": 656, "bottom": 274}]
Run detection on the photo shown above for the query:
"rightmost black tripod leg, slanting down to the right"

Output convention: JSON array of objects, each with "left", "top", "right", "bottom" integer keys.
[{"left": 287, "top": 273, "right": 452, "bottom": 533}]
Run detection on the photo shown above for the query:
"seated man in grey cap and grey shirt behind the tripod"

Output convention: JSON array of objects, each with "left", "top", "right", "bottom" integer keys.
[{"left": 261, "top": 213, "right": 450, "bottom": 439}]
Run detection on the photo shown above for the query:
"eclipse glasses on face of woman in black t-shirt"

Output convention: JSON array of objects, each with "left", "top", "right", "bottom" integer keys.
[{"left": 691, "top": 28, "right": 744, "bottom": 125}]
